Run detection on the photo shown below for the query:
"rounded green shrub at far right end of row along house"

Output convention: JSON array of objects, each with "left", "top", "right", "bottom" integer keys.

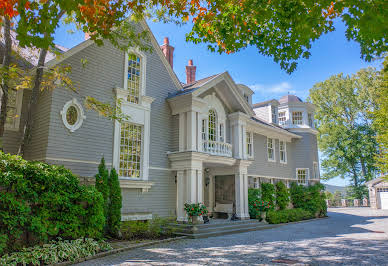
[{"left": 290, "top": 182, "right": 327, "bottom": 217}]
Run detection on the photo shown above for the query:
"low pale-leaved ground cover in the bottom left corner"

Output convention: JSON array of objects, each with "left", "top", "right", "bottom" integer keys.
[{"left": 0, "top": 238, "right": 112, "bottom": 266}]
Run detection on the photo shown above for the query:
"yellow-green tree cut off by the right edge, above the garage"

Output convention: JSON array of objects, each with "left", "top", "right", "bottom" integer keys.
[{"left": 373, "top": 56, "right": 388, "bottom": 174}]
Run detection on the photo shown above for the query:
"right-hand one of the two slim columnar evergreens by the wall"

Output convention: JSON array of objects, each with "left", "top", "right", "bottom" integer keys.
[{"left": 108, "top": 168, "right": 122, "bottom": 237}]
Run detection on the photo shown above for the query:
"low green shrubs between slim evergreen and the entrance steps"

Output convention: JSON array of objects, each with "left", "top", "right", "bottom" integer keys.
[{"left": 121, "top": 217, "right": 175, "bottom": 240}]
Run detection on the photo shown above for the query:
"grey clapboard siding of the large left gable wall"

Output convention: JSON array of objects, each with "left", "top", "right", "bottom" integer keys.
[{"left": 47, "top": 35, "right": 178, "bottom": 216}]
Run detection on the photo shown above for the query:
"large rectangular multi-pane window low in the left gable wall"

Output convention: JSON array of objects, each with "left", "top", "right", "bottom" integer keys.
[{"left": 119, "top": 122, "right": 143, "bottom": 178}]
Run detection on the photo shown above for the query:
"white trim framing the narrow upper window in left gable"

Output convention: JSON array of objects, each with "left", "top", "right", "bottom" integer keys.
[{"left": 124, "top": 47, "right": 147, "bottom": 105}]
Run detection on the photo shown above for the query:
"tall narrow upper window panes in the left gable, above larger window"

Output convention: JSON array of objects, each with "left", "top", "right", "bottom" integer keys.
[{"left": 127, "top": 53, "right": 142, "bottom": 103}]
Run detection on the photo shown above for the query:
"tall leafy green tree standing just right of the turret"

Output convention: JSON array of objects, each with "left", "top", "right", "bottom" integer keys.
[{"left": 309, "top": 68, "right": 380, "bottom": 198}]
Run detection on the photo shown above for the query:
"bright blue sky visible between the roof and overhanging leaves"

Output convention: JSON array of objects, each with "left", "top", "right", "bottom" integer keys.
[{"left": 55, "top": 19, "right": 381, "bottom": 185}]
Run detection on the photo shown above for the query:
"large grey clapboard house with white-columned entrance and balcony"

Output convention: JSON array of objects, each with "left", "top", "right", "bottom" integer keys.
[{"left": 1, "top": 20, "right": 320, "bottom": 221}]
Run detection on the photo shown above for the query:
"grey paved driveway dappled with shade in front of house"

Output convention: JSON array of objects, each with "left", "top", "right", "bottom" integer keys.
[{"left": 78, "top": 208, "right": 388, "bottom": 265}]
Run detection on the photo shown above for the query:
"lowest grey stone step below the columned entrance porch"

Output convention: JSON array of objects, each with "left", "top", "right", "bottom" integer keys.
[{"left": 176, "top": 223, "right": 279, "bottom": 238}]
